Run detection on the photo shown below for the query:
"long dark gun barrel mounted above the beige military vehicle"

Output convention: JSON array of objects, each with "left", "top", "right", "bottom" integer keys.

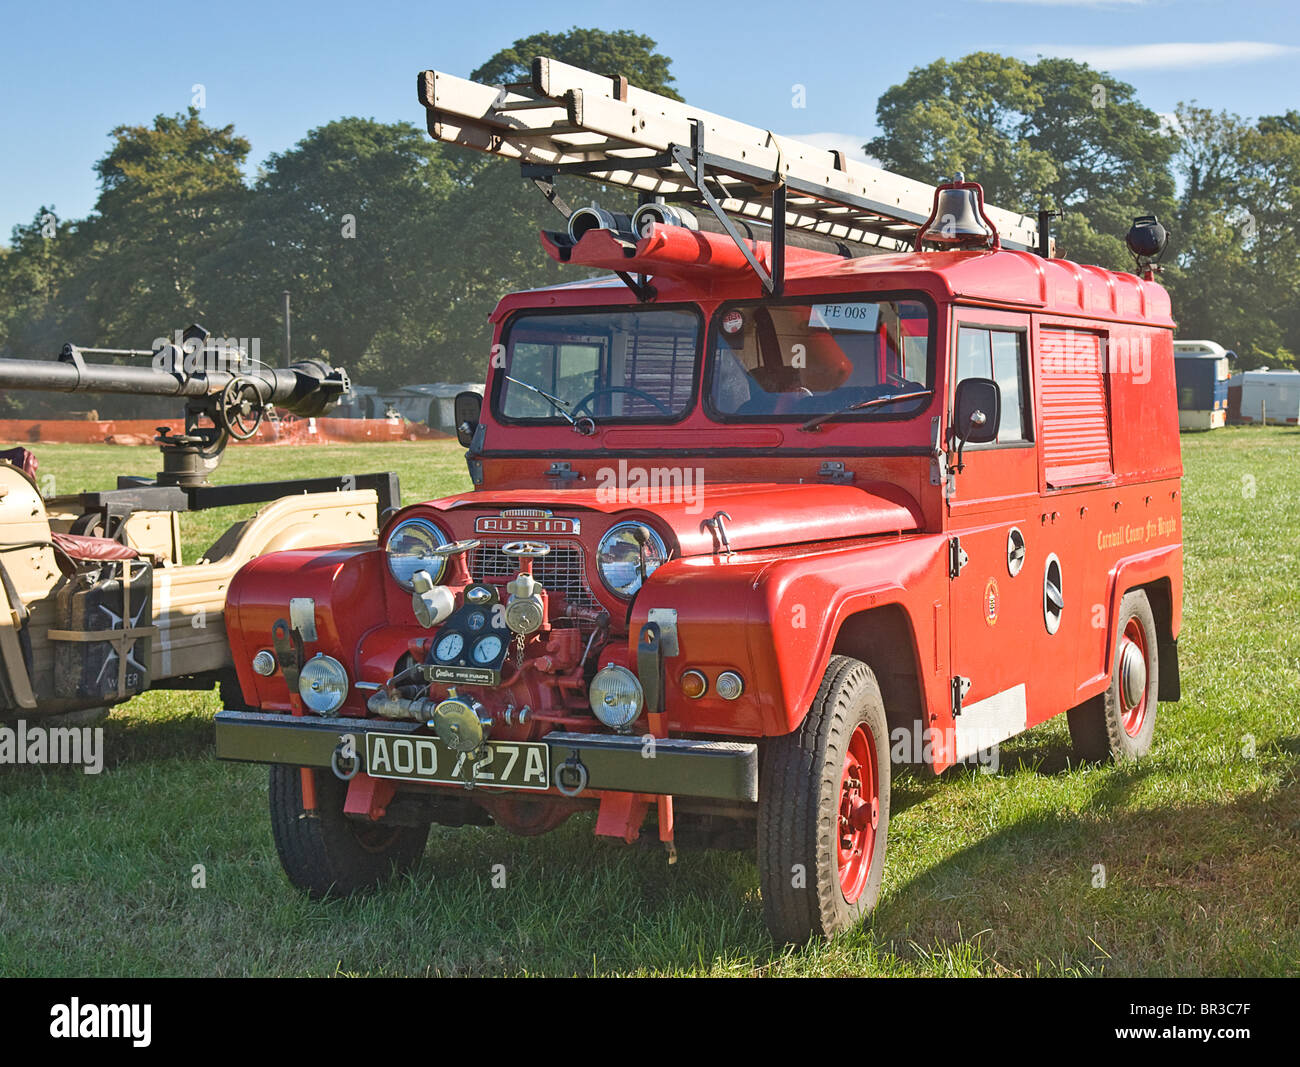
[{"left": 0, "top": 348, "right": 348, "bottom": 417}]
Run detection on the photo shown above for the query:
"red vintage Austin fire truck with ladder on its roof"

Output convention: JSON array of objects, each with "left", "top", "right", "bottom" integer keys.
[{"left": 216, "top": 58, "right": 1182, "bottom": 942}]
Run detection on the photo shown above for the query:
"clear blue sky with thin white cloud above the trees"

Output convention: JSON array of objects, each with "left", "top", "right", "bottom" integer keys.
[{"left": 0, "top": 0, "right": 1300, "bottom": 239}]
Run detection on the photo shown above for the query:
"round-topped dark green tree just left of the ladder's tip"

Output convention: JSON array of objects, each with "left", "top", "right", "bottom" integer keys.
[{"left": 222, "top": 117, "right": 452, "bottom": 385}]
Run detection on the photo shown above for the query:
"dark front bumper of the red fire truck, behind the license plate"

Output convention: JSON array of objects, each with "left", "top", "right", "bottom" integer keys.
[{"left": 217, "top": 711, "right": 758, "bottom": 801}]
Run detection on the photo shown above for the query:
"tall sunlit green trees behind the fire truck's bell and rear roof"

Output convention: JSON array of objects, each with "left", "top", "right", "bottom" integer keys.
[{"left": 866, "top": 53, "right": 1300, "bottom": 368}]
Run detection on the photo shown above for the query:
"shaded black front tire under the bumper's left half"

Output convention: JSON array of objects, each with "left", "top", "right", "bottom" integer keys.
[{"left": 270, "top": 763, "right": 429, "bottom": 899}]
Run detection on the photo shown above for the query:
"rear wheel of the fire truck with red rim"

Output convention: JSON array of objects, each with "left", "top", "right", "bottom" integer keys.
[{"left": 1066, "top": 589, "right": 1160, "bottom": 763}]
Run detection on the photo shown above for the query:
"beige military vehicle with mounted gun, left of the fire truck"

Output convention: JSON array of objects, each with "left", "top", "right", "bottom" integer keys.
[{"left": 0, "top": 326, "right": 400, "bottom": 720}]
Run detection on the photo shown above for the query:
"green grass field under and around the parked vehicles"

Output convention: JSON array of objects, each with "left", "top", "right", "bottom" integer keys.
[{"left": 0, "top": 429, "right": 1300, "bottom": 976}]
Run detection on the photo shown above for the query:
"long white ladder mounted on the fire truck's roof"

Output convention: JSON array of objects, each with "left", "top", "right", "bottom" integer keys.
[{"left": 419, "top": 57, "right": 1039, "bottom": 272}]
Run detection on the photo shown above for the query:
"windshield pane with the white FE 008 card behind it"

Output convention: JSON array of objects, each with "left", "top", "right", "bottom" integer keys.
[{"left": 709, "top": 299, "right": 935, "bottom": 420}]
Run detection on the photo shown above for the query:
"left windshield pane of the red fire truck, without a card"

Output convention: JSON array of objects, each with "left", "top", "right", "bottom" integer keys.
[{"left": 495, "top": 308, "right": 701, "bottom": 422}]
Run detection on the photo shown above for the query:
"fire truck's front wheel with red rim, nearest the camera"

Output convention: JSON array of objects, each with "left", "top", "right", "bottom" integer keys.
[{"left": 758, "top": 656, "right": 889, "bottom": 944}]
